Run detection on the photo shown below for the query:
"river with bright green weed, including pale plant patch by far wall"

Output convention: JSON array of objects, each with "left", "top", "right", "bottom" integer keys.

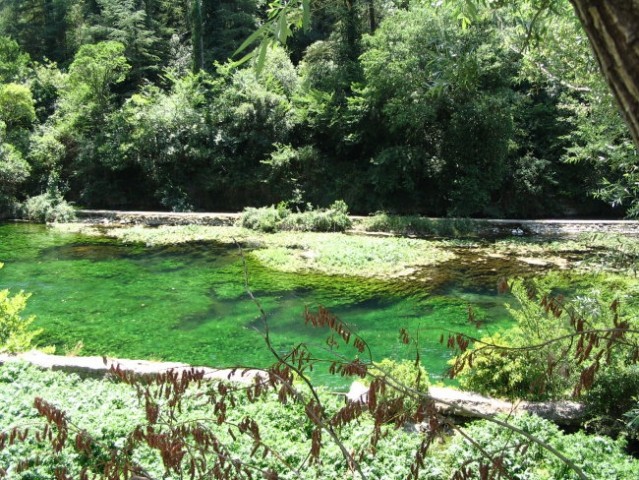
[{"left": 6, "top": 224, "right": 636, "bottom": 381}]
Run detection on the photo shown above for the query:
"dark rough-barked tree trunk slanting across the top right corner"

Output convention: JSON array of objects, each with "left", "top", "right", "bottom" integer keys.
[{"left": 570, "top": 0, "right": 639, "bottom": 149}]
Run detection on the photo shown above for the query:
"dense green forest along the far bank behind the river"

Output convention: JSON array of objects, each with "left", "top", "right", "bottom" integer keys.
[{"left": 0, "top": 0, "right": 637, "bottom": 218}]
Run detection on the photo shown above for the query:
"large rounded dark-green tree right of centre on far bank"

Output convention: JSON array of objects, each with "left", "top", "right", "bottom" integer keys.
[{"left": 351, "top": 8, "right": 514, "bottom": 216}]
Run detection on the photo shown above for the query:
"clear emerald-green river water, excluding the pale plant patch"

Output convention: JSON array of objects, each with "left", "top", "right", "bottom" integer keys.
[{"left": 0, "top": 223, "right": 520, "bottom": 383}]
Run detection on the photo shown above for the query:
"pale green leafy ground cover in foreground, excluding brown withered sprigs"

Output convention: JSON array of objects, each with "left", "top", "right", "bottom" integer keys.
[{"left": 0, "top": 363, "right": 639, "bottom": 480}]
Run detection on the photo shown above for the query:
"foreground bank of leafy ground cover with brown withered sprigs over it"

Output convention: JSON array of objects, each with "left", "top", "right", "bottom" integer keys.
[{"left": 0, "top": 362, "right": 639, "bottom": 480}]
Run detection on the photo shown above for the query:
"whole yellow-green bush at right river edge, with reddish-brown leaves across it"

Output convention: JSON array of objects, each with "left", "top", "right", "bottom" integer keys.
[{"left": 451, "top": 281, "right": 639, "bottom": 404}]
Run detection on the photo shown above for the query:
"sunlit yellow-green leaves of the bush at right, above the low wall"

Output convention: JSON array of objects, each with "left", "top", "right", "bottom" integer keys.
[{"left": 451, "top": 282, "right": 636, "bottom": 400}]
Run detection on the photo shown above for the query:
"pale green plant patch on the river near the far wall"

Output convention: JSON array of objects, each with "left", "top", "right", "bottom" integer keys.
[{"left": 56, "top": 224, "right": 455, "bottom": 278}]
